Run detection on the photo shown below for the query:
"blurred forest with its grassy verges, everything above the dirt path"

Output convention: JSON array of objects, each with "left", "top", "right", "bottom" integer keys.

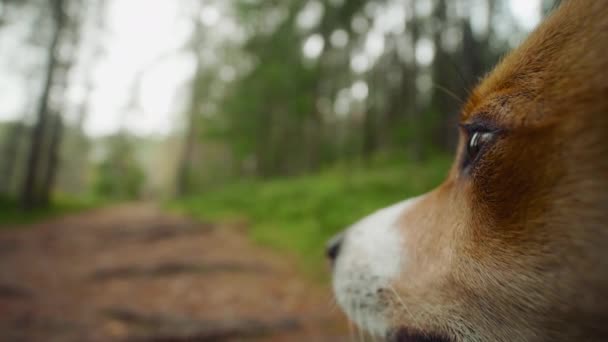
[{"left": 0, "top": 0, "right": 557, "bottom": 340}]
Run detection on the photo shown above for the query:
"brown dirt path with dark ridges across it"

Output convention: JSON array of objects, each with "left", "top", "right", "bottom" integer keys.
[{"left": 0, "top": 204, "right": 348, "bottom": 341}]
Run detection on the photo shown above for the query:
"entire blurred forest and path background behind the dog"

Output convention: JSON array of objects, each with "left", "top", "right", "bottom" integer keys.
[{"left": 0, "top": 0, "right": 556, "bottom": 341}]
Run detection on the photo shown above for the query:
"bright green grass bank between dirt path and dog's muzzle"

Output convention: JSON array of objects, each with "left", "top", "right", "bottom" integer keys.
[{"left": 170, "top": 158, "right": 449, "bottom": 280}]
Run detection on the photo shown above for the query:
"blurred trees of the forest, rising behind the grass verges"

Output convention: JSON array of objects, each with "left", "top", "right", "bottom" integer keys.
[{"left": 0, "top": 0, "right": 553, "bottom": 203}]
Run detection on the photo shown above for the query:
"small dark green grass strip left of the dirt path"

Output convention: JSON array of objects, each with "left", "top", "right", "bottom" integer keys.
[{"left": 0, "top": 196, "right": 101, "bottom": 229}]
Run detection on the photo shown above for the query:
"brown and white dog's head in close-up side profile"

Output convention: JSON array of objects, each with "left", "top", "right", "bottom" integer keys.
[{"left": 329, "top": 0, "right": 608, "bottom": 341}]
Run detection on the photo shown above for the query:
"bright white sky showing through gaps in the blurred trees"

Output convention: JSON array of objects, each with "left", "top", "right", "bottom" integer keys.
[{"left": 0, "top": 0, "right": 541, "bottom": 136}]
